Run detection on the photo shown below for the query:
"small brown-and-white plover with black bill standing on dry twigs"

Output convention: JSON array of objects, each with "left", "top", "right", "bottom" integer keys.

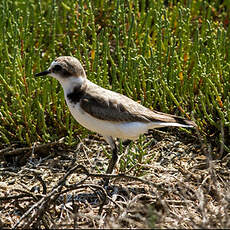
[{"left": 35, "top": 56, "right": 195, "bottom": 184}]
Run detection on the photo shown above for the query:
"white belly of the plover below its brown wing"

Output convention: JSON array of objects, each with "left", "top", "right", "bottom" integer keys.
[{"left": 67, "top": 102, "right": 150, "bottom": 139}]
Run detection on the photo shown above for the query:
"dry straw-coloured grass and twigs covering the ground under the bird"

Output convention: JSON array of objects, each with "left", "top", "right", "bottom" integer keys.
[{"left": 0, "top": 131, "right": 230, "bottom": 228}]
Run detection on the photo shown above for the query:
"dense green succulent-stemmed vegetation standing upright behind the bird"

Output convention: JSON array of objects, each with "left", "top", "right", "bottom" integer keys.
[{"left": 0, "top": 0, "right": 230, "bottom": 150}]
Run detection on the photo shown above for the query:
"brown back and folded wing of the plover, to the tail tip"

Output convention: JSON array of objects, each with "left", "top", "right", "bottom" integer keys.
[{"left": 80, "top": 85, "right": 193, "bottom": 125}]
